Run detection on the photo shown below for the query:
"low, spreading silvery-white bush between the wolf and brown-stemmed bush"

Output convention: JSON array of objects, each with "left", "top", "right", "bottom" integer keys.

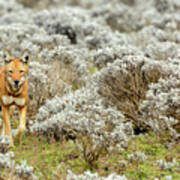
[{"left": 31, "top": 75, "right": 133, "bottom": 148}]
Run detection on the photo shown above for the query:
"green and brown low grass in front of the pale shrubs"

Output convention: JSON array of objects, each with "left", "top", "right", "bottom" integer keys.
[{"left": 13, "top": 133, "right": 180, "bottom": 180}]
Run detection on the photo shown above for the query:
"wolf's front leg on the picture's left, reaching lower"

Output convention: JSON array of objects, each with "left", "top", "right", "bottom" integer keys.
[{"left": 2, "top": 106, "right": 14, "bottom": 147}]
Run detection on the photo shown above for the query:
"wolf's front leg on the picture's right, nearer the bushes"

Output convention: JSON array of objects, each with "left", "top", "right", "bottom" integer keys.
[{"left": 15, "top": 106, "right": 26, "bottom": 142}]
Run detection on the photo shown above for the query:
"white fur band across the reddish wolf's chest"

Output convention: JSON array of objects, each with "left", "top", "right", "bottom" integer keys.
[{"left": 2, "top": 96, "right": 25, "bottom": 106}]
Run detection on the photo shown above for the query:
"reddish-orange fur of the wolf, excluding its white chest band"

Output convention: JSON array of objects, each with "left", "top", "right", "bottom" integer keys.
[{"left": 0, "top": 54, "right": 29, "bottom": 146}]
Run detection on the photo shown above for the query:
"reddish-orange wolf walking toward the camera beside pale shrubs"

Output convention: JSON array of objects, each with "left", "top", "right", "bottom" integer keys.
[{"left": 0, "top": 50, "right": 29, "bottom": 146}]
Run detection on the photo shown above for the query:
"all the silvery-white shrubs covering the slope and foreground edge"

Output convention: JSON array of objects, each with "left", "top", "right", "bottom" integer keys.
[{"left": 0, "top": 0, "right": 180, "bottom": 179}]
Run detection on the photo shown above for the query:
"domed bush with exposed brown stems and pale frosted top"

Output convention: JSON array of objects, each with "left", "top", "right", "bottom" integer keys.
[{"left": 99, "top": 56, "right": 171, "bottom": 126}]
